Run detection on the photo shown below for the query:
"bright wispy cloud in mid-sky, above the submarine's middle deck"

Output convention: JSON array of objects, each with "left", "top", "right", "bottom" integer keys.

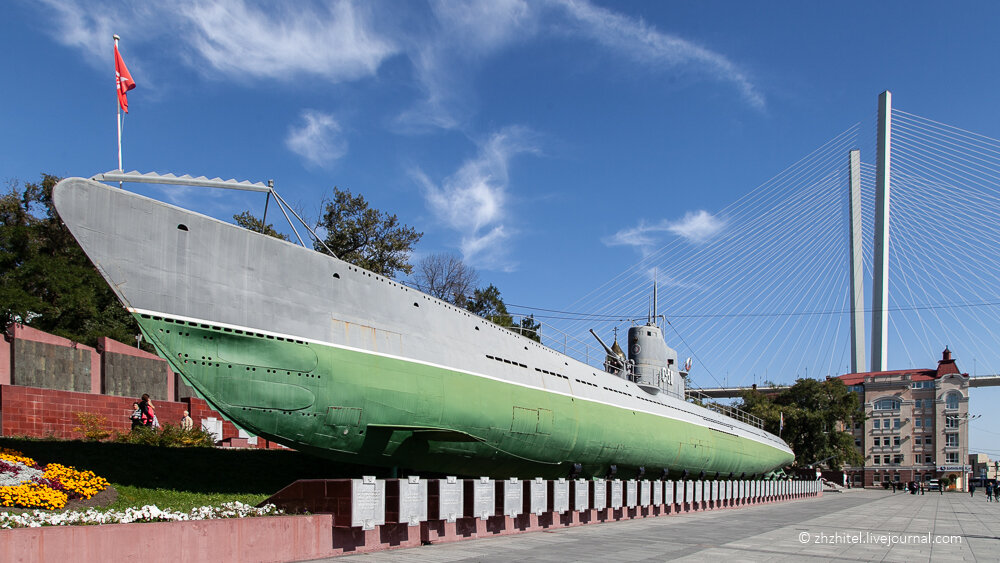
[{"left": 413, "top": 127, "right": 537, "bottom": 270}]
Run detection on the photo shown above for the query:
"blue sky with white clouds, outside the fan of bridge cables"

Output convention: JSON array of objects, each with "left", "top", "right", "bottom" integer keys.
[{"left": 0, "top": 0, "right": 1000, "bottom": 453}]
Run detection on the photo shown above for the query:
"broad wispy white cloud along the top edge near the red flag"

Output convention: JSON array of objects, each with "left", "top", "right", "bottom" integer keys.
[{"left": 43, "top": 0, "right": 399, "bottom": 83}]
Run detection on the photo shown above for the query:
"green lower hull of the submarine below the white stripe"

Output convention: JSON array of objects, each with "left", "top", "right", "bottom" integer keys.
[{"left": 141, "top": 314, "right": 793, "bottom": 478}]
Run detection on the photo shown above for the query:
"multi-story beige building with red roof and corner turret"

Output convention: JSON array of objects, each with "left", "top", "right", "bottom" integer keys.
[{"left": 840, "top": 348, "right": 971, "bottom": 490}]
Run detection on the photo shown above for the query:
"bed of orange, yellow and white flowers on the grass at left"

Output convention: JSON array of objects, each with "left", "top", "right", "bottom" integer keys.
[{"left": 0, "top": 449, "right": 108, "bottom": 510}]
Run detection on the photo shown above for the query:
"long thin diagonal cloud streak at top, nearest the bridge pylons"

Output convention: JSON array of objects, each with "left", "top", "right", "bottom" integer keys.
[{"left": 551, "top": 0, "right": 765, "bottom": 109}]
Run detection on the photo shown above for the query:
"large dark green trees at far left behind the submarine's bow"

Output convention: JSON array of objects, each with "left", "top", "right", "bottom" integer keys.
[{"left": 0, "top": 174, "right": 139, "bottom": 346}]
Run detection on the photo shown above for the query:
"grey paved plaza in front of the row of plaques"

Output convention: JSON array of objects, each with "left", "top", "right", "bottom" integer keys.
[{"left": 322, "top": 489, "right": 1000, "bottom": 563}]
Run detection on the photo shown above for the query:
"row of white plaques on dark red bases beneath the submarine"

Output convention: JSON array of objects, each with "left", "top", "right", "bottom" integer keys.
[{"left": 337, "top": 477, "right": 821, "bottom": 530}]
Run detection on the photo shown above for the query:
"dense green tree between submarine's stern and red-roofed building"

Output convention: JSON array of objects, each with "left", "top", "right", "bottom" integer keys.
[{"left": 740, "top": 378, "right": 864, "bottom": 469}]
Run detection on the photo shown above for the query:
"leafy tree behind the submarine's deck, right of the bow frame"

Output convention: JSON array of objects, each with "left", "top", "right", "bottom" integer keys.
[{"left": 313, "top": 188, "right": 424, "bottom": 278}]
